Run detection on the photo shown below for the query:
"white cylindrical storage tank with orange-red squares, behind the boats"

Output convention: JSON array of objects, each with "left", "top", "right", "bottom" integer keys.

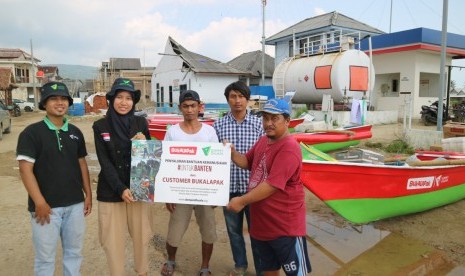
[{"left": 273, "top": 50, "right": 375, "bottom": 104}]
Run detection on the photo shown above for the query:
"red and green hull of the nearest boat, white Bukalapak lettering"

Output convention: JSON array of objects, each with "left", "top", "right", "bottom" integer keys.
[{"left": 301, "top": 160, "right": 465, "bottom": 223}]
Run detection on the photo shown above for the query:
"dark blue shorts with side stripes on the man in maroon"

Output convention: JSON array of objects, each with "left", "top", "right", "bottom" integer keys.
[{"left": 251, "top": 237, "right": 312, "bottom": 276}]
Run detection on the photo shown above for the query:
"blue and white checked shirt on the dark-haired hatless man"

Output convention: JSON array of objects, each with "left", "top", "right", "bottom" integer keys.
[{"left": 213, "top": 111, "right": 265, "bottom": 194}]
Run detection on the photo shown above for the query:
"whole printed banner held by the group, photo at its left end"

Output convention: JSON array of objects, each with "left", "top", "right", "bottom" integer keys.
[{"left": 131, "top": 140, "right": 231, "bottom": 206}]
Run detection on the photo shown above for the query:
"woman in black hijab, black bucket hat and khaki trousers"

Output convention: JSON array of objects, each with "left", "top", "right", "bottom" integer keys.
[{"left": 92, "top": 78, "right": 152, "bottom": 276}]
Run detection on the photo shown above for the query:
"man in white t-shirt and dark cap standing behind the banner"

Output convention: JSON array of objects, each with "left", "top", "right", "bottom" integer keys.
[{"left": 161, "top": 90, "right": 218, "bottom": 276}]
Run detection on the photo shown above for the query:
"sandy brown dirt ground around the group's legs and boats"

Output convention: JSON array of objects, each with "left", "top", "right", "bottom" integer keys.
[{"left": 0, "top": 112, "right": 465, "bottom": 275}]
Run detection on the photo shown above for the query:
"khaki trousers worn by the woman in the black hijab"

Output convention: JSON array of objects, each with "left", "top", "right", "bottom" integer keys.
[{"left": 98, "top": 201, "right": 152, "bottom": 276}]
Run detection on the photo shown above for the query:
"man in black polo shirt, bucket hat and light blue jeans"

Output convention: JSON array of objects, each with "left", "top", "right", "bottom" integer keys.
[{"left": 16, "top": 82, "right": 92, "bottom": 275}]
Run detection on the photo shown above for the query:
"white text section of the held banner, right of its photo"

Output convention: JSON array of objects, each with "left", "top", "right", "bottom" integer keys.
[{"left": 155, "top": 141, "right": 231, "bottom": 206}]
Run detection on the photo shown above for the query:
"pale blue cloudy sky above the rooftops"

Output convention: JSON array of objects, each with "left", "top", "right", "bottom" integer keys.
[{"left": 0, "top": 0, "right": 465, "bottom": 84}]
